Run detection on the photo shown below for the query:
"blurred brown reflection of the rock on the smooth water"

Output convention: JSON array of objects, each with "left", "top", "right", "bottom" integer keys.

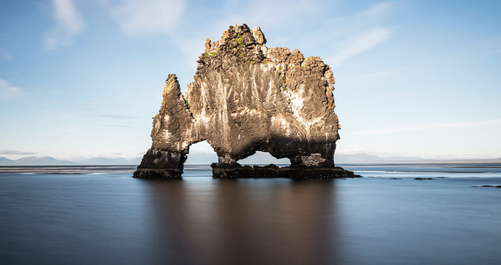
[{"left": 145, "top": 178, "right": 341, "bottom": 264}]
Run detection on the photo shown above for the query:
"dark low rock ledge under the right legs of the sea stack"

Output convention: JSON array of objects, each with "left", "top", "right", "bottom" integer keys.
[{"left": 211, "top": 163, "right": 361, "bottom": 179}]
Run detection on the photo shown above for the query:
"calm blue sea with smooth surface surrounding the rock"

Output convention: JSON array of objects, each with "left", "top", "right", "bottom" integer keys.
[{"left": 0, "top": 163, "right": 501, "bottom": 265}]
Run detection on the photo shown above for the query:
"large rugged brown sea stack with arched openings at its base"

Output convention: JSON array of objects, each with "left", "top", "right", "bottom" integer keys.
[{"left": 134, "top": 24, "right": 358, "bottom": 178}]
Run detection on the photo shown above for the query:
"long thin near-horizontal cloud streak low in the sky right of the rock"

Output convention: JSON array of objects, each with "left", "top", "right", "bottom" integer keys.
[{"left": 353, "top": 119, "right": 501, "bottom": 135}]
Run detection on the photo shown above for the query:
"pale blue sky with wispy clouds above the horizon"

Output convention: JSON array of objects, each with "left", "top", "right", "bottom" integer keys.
[{"left": 0, "top": 0, "right": 501, "bottom": 160}]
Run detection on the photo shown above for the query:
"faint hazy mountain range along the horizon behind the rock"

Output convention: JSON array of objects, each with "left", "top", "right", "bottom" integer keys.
[{"left": 0, "top": 152, "right": 501, "bottom": 166}]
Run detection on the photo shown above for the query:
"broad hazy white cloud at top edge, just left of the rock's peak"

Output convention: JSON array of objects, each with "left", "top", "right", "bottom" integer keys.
[{"left": 104, "top": 0, "right": 185, "bottom": 36}]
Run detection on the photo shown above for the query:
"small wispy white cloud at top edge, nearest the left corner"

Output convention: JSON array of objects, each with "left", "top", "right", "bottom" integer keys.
[{"left": 43, "top": 0, "right": 85, "bottom": 49}]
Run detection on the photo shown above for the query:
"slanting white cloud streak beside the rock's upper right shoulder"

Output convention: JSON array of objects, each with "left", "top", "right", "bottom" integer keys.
[{"left": 332, "top": 27, "right": 392, "bottom": 67}]
